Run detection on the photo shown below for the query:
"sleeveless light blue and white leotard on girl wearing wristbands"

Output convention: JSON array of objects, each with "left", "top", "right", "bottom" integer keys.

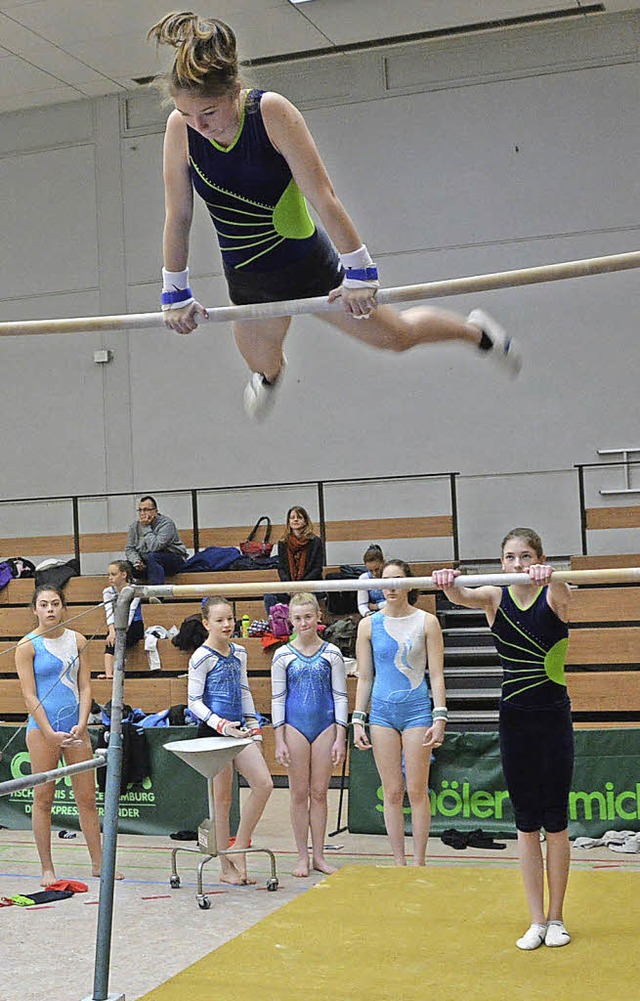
[{"left": 370, "top": 609, "right": 432, "bottom": 732}]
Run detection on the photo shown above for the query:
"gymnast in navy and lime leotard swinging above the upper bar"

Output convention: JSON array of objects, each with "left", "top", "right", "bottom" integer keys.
[{"left": 149, "top": 11, "right": 521, "bottom": 419}]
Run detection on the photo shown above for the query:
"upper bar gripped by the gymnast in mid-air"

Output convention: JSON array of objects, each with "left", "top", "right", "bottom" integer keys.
[{"left": 0, "top": 250, "right": 640, "bottom": 337}]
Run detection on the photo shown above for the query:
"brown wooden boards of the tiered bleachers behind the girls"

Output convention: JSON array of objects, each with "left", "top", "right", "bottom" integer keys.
[{"left": 0, "top": 507, "right": 640, "bottom": 725}]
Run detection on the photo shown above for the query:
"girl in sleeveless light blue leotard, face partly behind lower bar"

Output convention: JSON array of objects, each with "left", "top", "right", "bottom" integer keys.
[{"left": 352, "top": 560, "right": 447, "bottom": 866}]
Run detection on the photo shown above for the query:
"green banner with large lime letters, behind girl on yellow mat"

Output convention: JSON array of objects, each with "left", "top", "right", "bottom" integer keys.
[{"left": 349, "top": 729, "right": 640, "bottom": 838}]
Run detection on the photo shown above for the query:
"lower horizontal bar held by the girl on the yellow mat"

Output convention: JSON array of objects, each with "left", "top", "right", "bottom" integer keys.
[{"left": 134, "top": 567, "right": 640, "bottom": 598}]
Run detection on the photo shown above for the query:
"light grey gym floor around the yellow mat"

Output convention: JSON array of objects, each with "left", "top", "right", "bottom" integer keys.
[{"left": 0, "top": 790, "right": 640, "bottom": 1001}]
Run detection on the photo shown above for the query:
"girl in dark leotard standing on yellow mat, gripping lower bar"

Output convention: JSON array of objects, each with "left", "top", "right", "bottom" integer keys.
[{"left": 433, "top": 529, "right": 574, "bottom": 949}]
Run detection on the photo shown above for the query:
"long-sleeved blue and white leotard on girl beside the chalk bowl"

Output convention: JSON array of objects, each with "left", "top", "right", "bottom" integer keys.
[{"left": 188, "top": 643, "right": 256, "bottom": 730}]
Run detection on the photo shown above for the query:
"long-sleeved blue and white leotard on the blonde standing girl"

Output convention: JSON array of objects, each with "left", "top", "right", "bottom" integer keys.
[{"left": 271, "top": 643, "right": 348, "bottom": 744}]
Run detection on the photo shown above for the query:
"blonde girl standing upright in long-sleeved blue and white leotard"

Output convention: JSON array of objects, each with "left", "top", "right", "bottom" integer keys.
[{"left": 271, "top": 593, "right": 348, "bottom": 877}]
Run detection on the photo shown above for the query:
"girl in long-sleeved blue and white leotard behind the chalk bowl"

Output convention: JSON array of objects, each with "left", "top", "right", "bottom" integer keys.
[{"left": 188, "top": 598, "right": 273, "bottom": 885}]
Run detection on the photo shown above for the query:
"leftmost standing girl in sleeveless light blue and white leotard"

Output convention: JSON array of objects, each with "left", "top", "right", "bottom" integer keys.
[{"left": 16, "top": 585, "right": 116, "bottom": 887}]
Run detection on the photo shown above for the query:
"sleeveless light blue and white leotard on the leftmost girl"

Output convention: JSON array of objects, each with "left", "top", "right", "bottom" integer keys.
[{"left": 27, "top": 629, "right": 80, "bottom": 733}]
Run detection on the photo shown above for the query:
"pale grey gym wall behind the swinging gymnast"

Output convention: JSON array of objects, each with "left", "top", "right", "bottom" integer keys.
[{"left": 0, "top": 14, "right": 640, "bottom": 558}]
